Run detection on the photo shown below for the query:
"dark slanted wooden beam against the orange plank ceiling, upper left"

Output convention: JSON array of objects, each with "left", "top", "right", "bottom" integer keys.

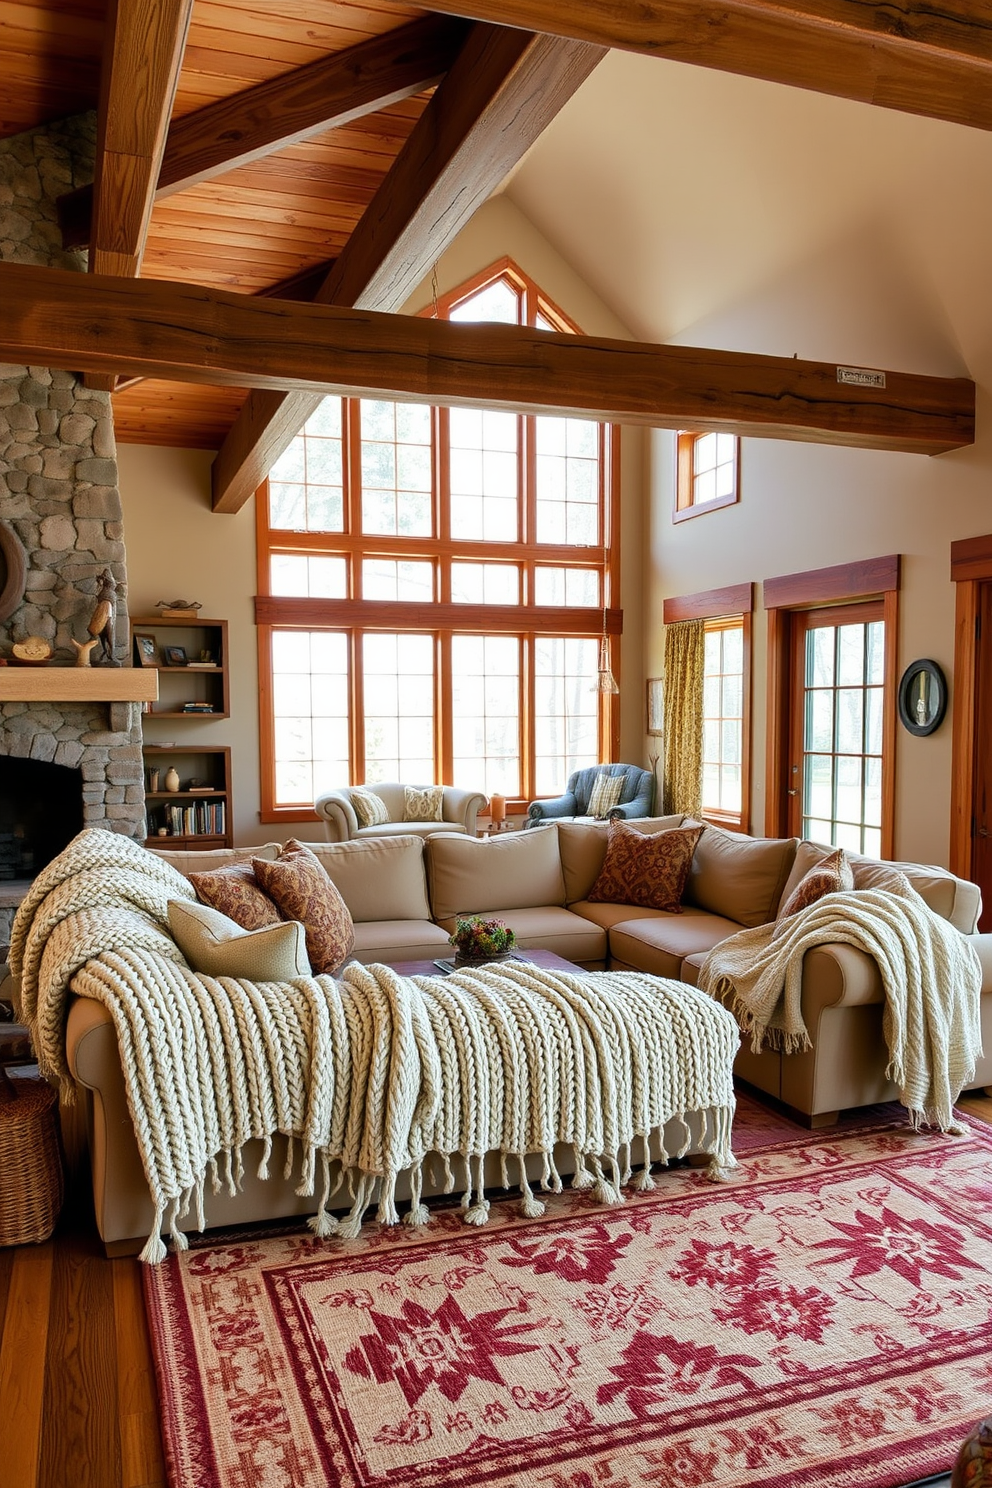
[{"left": 58, "top": 15, "right": 468, "bottom": 248}]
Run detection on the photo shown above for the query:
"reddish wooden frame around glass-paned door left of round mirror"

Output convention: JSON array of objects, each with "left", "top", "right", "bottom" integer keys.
[{"left": 763, "top": 554, "right": 901, "bottom": 859}]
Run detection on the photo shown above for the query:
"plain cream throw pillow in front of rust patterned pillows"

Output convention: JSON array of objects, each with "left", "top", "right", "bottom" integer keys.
[{"left": 168, "top": 899, "right": 311, "bottom": 982}]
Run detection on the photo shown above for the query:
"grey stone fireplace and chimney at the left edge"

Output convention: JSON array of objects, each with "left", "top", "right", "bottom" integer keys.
[{"left": 0, "top": 115, "right": 144, "bottom": 942}]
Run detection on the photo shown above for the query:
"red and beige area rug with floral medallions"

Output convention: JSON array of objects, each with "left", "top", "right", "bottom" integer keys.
[{"left": 146, "top": 1109, "right": 992, "bottom": 1488}]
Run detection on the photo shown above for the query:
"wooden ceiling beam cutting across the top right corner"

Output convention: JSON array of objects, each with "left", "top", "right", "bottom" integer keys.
[{"left": 431, "top": 0, "right": 992, "bottom": 129}]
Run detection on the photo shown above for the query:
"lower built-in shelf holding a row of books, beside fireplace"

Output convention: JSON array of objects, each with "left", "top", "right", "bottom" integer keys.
[{"left": 141, "top": 744, "right": 233, "bottom": 850}]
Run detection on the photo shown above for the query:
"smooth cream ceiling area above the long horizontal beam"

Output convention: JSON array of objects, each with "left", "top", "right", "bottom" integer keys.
[{"left": 506, "top": 52, "right": 992, "bottom": 375}]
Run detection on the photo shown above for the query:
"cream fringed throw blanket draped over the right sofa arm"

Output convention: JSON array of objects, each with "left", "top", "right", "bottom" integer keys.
[{"left": 699, "top": 884, "right": 982, "bottom": 1131}]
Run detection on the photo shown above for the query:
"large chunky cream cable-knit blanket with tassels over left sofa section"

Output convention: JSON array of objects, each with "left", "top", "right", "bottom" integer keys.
[{"left": 12, "top": 830, "right": 739, "bottom": 1260}]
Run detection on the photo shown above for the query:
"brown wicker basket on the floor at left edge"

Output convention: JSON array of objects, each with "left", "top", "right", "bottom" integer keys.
[{"left": 0, "top": 1068, "right": 62, "bottom": 1245}]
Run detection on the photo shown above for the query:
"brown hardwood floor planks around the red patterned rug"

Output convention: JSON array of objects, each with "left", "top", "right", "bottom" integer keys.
[{"left": 0, "top": 1097, "right": 992, "bottom": 1488}]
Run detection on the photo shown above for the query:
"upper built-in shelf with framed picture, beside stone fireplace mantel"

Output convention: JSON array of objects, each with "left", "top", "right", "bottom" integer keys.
[{"left": 131, "top": 615, "right": 231, "bottom": 719}]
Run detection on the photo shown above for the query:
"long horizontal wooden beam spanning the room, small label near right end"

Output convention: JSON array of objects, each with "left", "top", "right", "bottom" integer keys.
[{"left": 0, "top": 263, "right": 976, "bottom": 454}]
